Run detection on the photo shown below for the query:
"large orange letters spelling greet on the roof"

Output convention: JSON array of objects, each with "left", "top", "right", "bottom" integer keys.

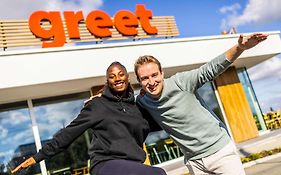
[{"left": 29, "top": 4, "right": 158, "bottom": 48}]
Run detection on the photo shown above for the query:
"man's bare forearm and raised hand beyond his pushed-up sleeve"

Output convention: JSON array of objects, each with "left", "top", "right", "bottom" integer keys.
[{"left": 225, "top": 33, "right": 268, "bottom": 62}]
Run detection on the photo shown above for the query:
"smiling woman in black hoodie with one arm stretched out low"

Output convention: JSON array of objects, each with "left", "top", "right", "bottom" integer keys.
[{"left": 12, "top": 62, "right": 166, "bottom": 175}]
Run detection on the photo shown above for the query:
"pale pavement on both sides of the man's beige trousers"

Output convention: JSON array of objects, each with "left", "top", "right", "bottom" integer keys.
[{"left": 160, "top": 128, "right": 281, "bottom": 175}]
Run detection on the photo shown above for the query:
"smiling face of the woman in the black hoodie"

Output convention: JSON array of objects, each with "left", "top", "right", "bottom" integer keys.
[{"left": 106, "top": 64, "right": 129, "bottom": 93}]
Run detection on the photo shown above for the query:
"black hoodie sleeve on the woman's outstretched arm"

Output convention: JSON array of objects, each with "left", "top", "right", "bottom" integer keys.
[{"left": 33, "top": 102, "right": 97, "bottom": 163}]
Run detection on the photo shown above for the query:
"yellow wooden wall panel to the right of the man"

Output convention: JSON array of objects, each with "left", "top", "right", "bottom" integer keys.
[{"left": 215, "top": 67, "right": 258, "bottom": 143}]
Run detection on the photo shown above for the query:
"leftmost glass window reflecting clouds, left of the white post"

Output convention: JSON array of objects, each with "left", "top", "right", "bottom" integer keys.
[{"left": 0, "top": 102, "right": 40, "bottom": 175}]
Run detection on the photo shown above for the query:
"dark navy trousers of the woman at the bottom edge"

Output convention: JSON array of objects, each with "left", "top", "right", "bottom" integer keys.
[{"left": 91, "top": 159, "right": 167, "bottom": 175}]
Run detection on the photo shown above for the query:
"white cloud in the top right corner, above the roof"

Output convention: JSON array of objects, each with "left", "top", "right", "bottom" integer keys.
[{"left": 220, "top": 0, "right": 281, "bottom": 30}]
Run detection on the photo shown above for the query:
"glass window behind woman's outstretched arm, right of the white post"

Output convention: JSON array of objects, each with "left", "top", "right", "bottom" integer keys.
[{"left": 33, "top": 92, "right": 90, "bottom": 174}]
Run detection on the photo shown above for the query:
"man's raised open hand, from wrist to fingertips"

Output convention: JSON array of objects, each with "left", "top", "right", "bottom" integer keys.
[{"left": 238, "top": 33, "right": 268, "bottom": 50}]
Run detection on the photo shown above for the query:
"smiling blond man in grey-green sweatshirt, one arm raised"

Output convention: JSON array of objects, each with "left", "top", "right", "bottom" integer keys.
[{"left": 135, "top": 33, "right": 268, "bottom": 175}]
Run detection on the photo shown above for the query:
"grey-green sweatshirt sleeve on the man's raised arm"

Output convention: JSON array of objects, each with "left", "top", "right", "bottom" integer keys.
[{"left": 172, "top": 54, "right": 231, "bottom": 92}]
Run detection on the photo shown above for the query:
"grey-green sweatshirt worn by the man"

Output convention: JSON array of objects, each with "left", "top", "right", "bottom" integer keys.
[{"left": 137, "top": 55, "right": 231, "bottom": 160}]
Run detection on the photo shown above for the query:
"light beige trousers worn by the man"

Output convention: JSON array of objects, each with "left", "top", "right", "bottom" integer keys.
[{"left": 186, "top": 142, "right": 245, "bottom": 175}]
